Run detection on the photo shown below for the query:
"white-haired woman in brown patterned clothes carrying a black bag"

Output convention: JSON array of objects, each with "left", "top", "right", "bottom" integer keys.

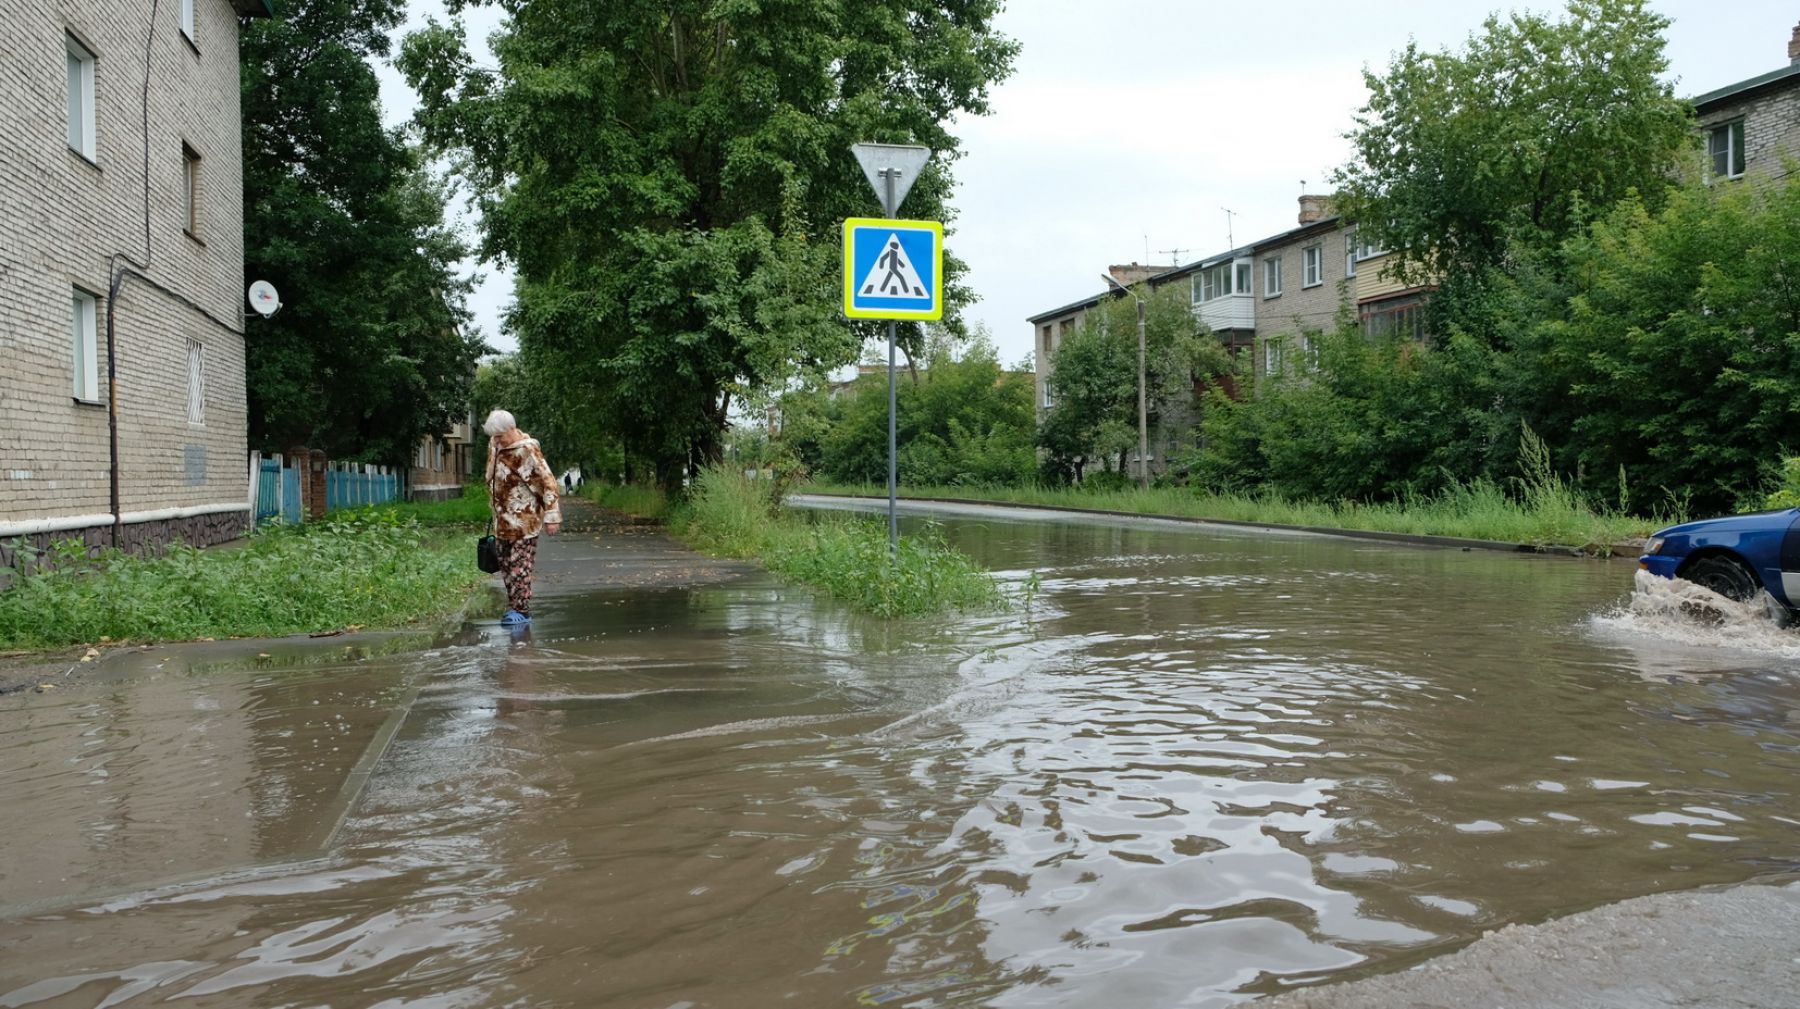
[{"left": 481, "top": 410, "right": 562, "bottom": 624}]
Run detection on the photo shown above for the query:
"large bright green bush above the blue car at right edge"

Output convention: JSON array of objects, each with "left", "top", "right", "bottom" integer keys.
[{"left": 1526, "top": 176, "right": 1800, "bottom": 511}]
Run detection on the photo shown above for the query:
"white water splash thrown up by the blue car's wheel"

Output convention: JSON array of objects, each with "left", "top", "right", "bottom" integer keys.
[{"left": 1591, "top": 570, "right": 1800, "bottom": 660}]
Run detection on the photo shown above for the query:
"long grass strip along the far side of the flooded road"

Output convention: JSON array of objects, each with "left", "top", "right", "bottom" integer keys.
[{"left": 805, "top": 480, "right": 1667, "bottom": 554}]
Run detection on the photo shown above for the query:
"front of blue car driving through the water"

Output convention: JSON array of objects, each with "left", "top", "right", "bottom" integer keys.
[{"left": 1638, "top": 507, "right": 1800, "bottom": 619}]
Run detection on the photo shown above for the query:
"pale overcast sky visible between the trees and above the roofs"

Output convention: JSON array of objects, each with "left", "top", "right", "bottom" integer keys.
[{"left": 382, "top": 0, "right": 1800, "bottom": 362}]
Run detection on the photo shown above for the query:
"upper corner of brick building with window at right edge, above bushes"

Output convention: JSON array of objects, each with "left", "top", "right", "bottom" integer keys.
[{"left": 1694, "top": 25, "right": 1800, "bottom": 178}]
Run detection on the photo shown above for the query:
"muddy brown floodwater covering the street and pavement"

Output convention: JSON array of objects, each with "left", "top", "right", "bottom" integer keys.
[{"left": 0, "top": 503, "right": 1800, "bottom": 1009}]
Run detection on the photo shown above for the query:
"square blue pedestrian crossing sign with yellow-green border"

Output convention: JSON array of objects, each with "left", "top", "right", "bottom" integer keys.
[{"left": 844, "top": 218, "right": 943, "bottom": 320}]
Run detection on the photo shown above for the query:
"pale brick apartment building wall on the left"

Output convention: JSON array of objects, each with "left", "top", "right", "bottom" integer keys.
[{"left": 0, "top": 0, "right": 268, "bottom": 563}]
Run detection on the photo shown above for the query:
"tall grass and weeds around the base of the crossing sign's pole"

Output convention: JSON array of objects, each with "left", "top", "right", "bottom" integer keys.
[{"left": 583, "top": 466, "right": 1006, "bottom": 617}]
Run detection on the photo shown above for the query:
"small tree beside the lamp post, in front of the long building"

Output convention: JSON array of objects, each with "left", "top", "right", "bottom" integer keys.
[{"left": 1037, "top": 284, "right": 1231, "bottom": 480}]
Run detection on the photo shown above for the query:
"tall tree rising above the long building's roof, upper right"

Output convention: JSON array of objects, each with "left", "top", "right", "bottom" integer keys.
[{"left": 1332, "top": 0, "right": 1696, "bottom": 282}]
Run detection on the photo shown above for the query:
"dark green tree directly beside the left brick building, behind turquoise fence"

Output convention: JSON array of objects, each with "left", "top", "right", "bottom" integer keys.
[{"left": 241, "top": 0, "right": 486, "bottom": 464}]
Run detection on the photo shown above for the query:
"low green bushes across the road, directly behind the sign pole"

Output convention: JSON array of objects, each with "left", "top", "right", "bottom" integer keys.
[{"left": 806, "top": 335, "right": 1037, "bottom": 484}]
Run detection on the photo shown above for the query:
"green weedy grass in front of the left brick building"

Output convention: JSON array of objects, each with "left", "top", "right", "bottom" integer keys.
[{"left": 0, "top": 507, "right": 488, "bottom": 647}]
